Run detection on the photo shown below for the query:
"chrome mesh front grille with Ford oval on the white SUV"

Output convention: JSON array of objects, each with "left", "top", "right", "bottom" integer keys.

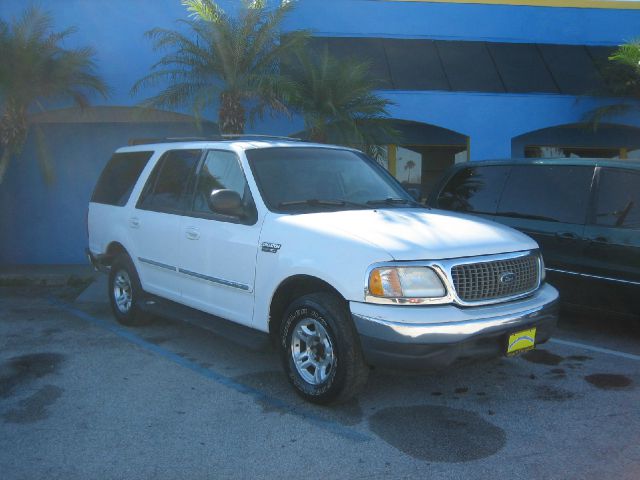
[{"left": 451, "top": 255, "right": 540, "bottom": 302}]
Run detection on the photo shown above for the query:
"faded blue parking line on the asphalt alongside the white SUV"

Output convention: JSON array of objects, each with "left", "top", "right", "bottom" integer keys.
[{"left": 48, "top": 297, "right": 371, "bottom": 442}]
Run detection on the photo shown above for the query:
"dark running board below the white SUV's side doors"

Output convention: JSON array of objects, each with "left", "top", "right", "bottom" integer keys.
[{"left": 140, "top": 295, "right": 271, "bottom": 351}]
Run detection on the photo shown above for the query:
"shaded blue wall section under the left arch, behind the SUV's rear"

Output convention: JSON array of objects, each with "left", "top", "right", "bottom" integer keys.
[{"left": 0, "top": 122, "right": 218, "bottom": 265}]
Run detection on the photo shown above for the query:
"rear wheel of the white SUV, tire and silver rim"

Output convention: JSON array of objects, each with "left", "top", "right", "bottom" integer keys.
[{"left": 107, "top": 254, "right": 150, "bottom": 327}]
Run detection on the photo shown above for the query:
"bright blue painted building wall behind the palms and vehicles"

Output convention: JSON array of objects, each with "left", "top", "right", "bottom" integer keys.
[{"left": 0, "top": 0, "right": 640, "bottom": 264}]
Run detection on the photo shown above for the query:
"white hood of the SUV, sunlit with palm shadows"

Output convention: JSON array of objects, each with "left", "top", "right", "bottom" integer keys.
[{"left": 281, "top": 208, "right": 538, "bottom": 260}]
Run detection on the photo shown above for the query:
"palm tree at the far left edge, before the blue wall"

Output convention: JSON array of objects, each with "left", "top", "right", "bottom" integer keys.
[{"left": 0, "top": 7, "right": 108, "bottom": 183}]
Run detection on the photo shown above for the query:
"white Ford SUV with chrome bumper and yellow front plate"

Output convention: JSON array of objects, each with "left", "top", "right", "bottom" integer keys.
[{"left": 88, "top": 139, "right": 558, "bottom": 403}]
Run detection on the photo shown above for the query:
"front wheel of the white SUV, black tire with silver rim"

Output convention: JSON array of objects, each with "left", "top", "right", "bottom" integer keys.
[{"left": 280, "top": 292, "right": 369, "bottom": 404}]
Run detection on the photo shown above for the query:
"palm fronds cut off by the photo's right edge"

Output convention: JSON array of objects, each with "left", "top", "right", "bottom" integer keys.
[{"left": 585, "top": 40, "right": 640, "bottom": 129}]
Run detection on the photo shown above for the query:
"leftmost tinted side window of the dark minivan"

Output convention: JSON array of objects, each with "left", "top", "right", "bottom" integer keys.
[{"left": 437, "top": 166, "right": 511, "bottom": 214}]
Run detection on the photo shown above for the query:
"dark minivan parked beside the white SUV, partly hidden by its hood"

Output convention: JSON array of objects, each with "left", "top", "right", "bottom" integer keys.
[{"left": 428, "top": 158, "right": 640, "bottom": 316}]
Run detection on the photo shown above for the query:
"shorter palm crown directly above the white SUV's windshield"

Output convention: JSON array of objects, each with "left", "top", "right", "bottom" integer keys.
[{"left": 287, "top": 48, "right": 399, "bottom": 158}]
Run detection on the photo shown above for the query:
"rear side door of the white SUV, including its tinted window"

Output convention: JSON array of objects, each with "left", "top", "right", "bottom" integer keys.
[{"left": 128, "top": 150, "right": 202, "bottom": 300}]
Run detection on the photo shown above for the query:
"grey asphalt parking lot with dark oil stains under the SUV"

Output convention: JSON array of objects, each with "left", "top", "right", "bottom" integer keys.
[{"left": 0, "top": 287, "right": 640, "bottom": 480}]
